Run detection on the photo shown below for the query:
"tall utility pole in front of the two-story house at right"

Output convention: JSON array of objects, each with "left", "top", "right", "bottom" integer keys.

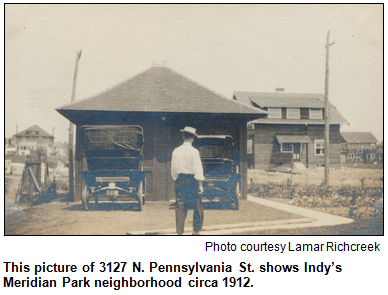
[{"left": 324, "top": 31, "right": 335, "bottom": 186}]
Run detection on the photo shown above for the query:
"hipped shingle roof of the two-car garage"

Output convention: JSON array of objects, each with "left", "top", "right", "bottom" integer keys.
[{"left": 57, "top": 67, "right": 267, "bottom": 117}]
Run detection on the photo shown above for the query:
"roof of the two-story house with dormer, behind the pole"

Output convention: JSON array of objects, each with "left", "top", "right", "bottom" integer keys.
[{"left": 234, "top": 91, "right": 348, "bottom": 124}]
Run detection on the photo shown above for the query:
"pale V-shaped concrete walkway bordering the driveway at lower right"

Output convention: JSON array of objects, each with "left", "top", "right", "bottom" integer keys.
[{"left": 127, "top": 195, "right": 353, "bottom": 235}]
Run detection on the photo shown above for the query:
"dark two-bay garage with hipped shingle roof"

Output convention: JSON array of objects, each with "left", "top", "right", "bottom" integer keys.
[{"left": 57, "top": 66, "right": 267, "bottom": 201}]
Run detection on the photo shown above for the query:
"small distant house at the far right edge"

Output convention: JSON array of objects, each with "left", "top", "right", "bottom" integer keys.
[{"left": 341, "top": 132, "right": 378, "bottom": 164}]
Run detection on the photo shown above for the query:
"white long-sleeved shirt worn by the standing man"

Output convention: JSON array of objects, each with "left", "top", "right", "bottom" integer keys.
[{"left": 171, "top": 142, "right": 205, "bottom": 180}]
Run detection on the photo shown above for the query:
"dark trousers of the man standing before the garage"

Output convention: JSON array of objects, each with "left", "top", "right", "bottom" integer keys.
[{"left": 175, "top": 174, "right": 203, "bottom": 234}]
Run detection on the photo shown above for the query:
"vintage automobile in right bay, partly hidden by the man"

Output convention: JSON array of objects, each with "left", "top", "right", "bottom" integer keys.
[{"left": 194, "top": 135, "right": 241, "bottom": 210}]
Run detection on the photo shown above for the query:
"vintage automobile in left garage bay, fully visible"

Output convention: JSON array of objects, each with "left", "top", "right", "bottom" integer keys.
[{"left": 81, "top": 125, "right": 146, "bottom": 211}]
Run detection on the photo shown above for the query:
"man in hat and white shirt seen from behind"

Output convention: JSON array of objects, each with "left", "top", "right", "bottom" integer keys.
[{"left": 171, "top": 126, "right": 204, "bottom": 235}]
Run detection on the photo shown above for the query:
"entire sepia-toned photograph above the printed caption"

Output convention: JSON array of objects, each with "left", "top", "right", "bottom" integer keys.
[{"left": 4, "top": 4, "right": 384, "bottom": 237}]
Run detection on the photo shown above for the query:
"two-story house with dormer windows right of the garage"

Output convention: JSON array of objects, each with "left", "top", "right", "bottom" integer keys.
[{"left": 233, "top": 88, "right": 348, "bottom": 170}]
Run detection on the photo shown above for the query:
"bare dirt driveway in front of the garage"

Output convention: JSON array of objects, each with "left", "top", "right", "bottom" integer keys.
[{"left": 5, "top": 200, "right": 303, "bottom": 235}]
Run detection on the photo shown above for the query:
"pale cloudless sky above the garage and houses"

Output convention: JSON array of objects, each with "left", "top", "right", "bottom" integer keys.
[{"left": 5, "top": 4, "right": 383, "bottom": 141}]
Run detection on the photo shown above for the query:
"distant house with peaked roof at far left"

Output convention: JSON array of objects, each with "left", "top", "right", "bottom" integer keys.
[{"left": 12, "top": 125, "right": 54, "bottom": 155}]
